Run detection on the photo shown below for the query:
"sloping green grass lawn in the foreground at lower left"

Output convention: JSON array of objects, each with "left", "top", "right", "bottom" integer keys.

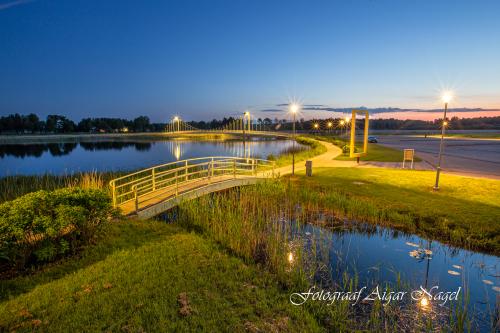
[{"left": 0, "top": 221, "right": 318, "bottom": 332}]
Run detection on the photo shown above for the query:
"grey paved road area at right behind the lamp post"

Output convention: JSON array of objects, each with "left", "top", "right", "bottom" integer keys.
[{"left": 378, "top": 135, "right": 500, "bottom": 179}]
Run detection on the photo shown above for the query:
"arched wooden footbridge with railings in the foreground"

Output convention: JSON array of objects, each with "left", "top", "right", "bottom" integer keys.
[{"left": 110, "top": 157, "right": 275, "bottom": 219}]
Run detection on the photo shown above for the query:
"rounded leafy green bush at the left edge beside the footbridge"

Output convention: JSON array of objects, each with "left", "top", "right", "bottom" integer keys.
[{"left": 0, "top": 187, "right": 113, "bottom": 269}]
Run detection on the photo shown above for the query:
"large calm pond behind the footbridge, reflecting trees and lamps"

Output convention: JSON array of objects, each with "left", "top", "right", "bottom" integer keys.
[{"left": 0, "top": 138, "right": 293, "bottom": 176}]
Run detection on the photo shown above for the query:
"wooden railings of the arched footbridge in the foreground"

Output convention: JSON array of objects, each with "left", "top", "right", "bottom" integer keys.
[{"left": 109, "top": 157, "right": 275, "bottom": 210}]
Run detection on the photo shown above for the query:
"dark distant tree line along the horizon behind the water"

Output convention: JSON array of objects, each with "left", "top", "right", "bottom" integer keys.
[{"left": 0, "top": 113, "right": 500, "bottom": 134}]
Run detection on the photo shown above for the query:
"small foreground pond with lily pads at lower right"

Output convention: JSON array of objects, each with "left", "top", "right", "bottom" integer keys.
[{"left": 290, "top": 214, "right": 500, "bottom": 331}]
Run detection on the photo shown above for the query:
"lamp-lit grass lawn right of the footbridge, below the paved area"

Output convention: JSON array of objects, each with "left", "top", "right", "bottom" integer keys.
[{"left": 290, "top": 168, "right": 500, "bottom": 255}]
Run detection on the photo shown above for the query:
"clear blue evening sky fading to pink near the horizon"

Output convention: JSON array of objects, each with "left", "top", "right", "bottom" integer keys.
[{"left": 0, "top": 0, "right": 500, "bottom": 121}]
